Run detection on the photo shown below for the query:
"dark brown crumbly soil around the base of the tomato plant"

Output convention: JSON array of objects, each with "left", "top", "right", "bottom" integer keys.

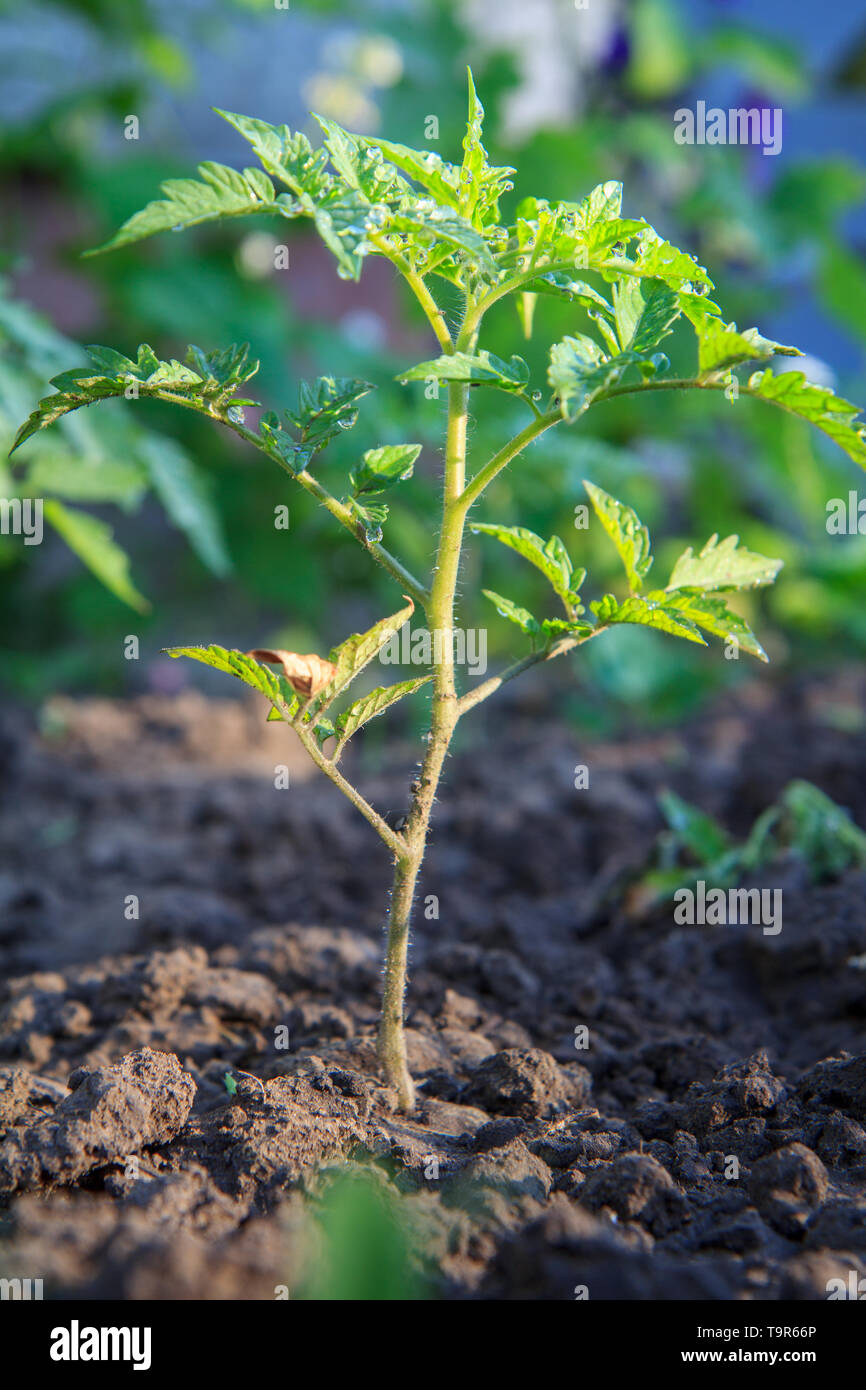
[{"left": 0, "top": 671, "right": 866, "bottom": 1300}]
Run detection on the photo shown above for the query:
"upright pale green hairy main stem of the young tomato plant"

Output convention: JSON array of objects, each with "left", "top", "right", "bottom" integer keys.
[{"left": 379, "top": 382, "right": 468, "bottom": 1111}]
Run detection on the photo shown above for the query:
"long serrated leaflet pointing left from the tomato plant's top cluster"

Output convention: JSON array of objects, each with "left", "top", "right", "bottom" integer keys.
[{"left": 85, "top": 160, "right": 279, "bottom": 256}]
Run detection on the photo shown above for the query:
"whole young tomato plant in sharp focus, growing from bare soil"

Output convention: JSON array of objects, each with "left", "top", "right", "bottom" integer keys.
[{"left": 15, "top": 74, "right": 866, "bottom": 1109}]
